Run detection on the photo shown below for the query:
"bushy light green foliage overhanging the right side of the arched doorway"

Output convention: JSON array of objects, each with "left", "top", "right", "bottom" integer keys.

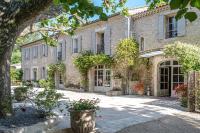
[{"left": 164, "top": 42, "right": 200, "bottom": 72}]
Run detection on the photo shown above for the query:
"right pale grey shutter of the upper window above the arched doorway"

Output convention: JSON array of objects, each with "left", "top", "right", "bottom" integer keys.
[{"left": 177, "top": 18, "right": 186, "bottom": 36}]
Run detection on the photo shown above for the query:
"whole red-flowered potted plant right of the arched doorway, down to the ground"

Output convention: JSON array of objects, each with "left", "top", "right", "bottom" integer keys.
[{"left": 175, "top": 84, "right": 188, "bottom": 107}]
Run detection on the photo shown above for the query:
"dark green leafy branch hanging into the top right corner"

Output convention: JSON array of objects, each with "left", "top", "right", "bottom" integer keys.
[{"left": 146, "top": 0, "right": 200, "bottom": 22}]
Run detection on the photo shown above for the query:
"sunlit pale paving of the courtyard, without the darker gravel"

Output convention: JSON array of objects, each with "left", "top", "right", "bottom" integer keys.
[{"left": 52, "top": 91, "right": 200, "bottom": 133}]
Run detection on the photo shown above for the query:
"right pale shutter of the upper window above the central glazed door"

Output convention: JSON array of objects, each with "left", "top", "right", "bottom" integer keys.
[{"left": 104, "top": 26, "right": 111, "bottom": 55}]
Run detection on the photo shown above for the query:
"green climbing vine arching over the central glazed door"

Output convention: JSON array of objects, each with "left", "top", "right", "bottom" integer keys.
[{"left": 74, "top": 51, "right": 113, "bottom": 87}]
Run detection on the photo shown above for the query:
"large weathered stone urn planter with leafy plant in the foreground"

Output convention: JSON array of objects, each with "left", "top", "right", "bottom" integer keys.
[{"left": 69, "top": 99, "right": 99, "bottom": 133}]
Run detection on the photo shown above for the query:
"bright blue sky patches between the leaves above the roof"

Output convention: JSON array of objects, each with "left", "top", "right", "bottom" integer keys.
[{"left": 93, "top": 0, "right": 146, "bottom": 8}]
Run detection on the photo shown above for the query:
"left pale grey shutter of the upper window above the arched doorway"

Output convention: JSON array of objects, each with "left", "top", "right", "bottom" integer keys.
[{"left": 158, "top": 15, "right": 165, "bottom": 39}]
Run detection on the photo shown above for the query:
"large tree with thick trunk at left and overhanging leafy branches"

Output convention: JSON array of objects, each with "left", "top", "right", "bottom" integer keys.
[{"left": 0, "top": 0, "right": 126, "bottom": 117}]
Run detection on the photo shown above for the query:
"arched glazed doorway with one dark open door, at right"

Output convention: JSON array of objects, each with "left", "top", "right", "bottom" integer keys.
[{"left": 158, "top": 60, "right": 184, "bottom": 97}]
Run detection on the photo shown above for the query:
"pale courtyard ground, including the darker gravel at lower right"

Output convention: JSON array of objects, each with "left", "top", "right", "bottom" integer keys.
[{"left": 51, "top": 91, "right": 200, "bottom": 133}]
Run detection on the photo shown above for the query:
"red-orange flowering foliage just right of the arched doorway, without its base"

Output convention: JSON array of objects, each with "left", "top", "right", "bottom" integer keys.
[{"left": 175, "top": 84, "right": 187, "bottom": 97}]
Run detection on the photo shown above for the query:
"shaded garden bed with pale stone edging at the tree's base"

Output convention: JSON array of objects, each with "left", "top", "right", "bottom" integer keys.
[{"left": 0, "top": 107, "right": 58, "bottom": 133}]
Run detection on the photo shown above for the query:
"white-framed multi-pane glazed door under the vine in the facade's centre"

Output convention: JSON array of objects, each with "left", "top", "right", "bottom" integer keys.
[{"left": 94, "top": 65, "right": 111, "bottom": 87}]
